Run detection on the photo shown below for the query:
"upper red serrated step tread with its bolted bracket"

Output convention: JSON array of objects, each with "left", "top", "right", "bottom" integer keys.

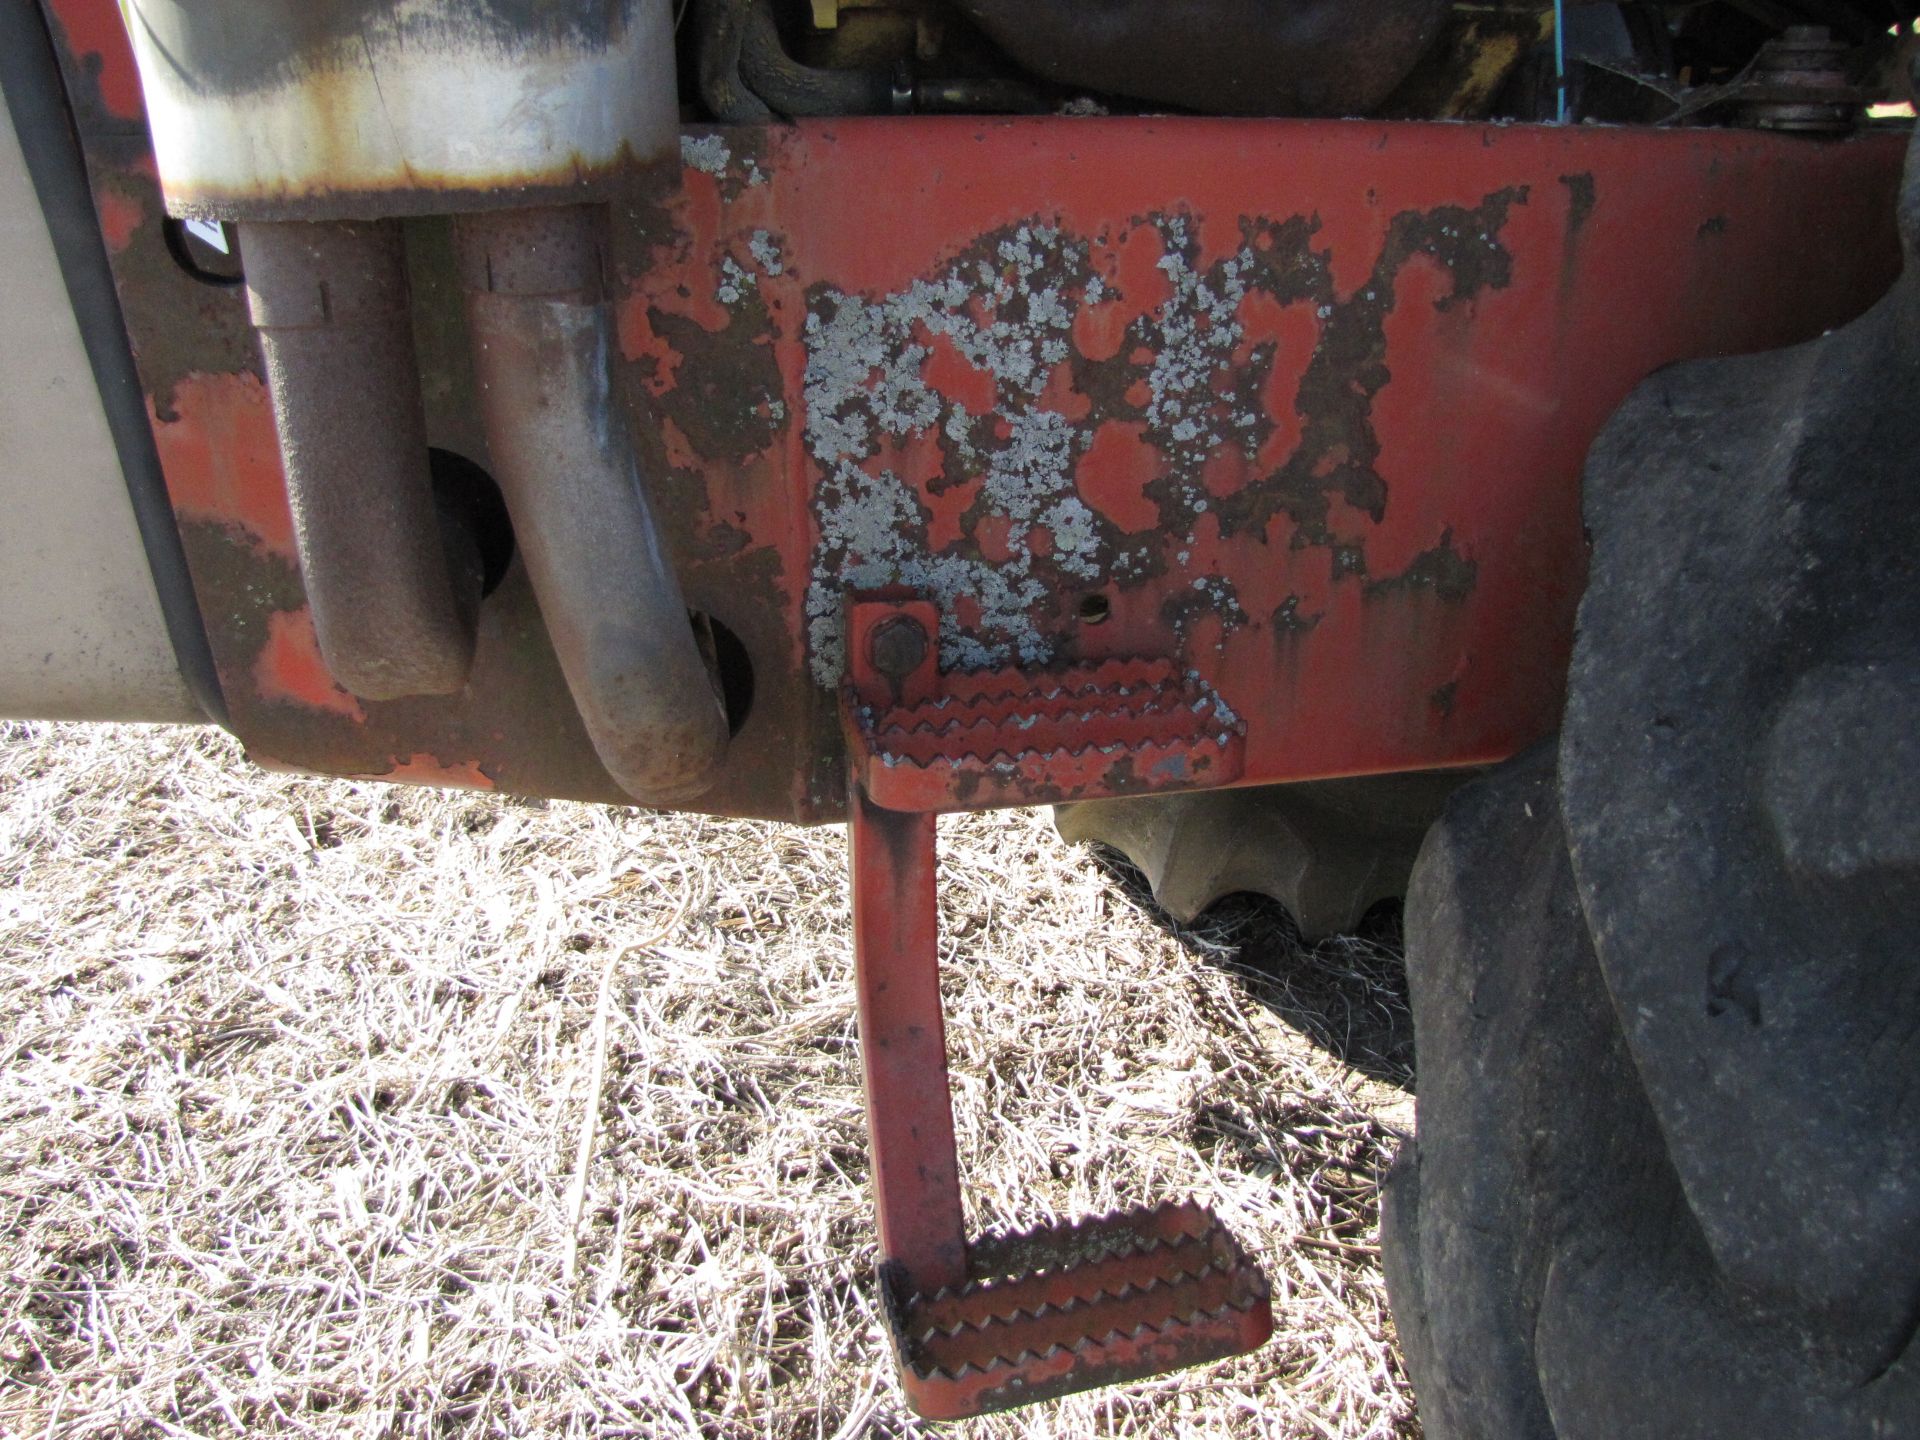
[{"left": 843, "top": 599, "right": 1246, "bottom": 812}]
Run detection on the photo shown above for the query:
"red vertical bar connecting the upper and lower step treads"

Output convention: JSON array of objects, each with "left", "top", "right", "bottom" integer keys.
[{"left": 847, "top": 785, "right": 966, "bottom": 1294}]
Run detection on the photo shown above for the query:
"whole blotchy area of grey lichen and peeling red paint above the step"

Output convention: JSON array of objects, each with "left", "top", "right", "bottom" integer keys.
[{"left": 798, "top": 190, "right": 1526, "bottom": 685}]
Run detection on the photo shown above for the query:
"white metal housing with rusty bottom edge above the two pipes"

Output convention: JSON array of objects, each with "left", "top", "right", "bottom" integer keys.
[{"left": 114, "top": 0, "right": 676, "bottom": 221}]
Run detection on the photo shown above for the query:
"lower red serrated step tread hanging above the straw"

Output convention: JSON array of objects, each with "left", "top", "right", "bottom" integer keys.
[{"left": 889, "top": 1204, "right": 1273, "bottom": 1421}]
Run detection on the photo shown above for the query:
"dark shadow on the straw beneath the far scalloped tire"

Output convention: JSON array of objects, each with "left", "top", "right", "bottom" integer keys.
[{"left": 1087, "top": 845, "right": 1413, "bottom": 1092}]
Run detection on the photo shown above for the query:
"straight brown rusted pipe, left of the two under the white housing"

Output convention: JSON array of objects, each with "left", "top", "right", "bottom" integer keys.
[{"left": 242, "top": 221, "right": 480, "bottom": 701}]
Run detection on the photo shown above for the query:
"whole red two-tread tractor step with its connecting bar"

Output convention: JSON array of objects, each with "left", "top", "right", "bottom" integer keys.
[{"left": 841, "top": 595, "right": 1273, "bottom": 1419}]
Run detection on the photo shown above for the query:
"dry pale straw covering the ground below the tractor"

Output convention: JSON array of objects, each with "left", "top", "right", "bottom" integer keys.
[{"left": 0, "top": 724, "right": 1415, "bottom": 1438}]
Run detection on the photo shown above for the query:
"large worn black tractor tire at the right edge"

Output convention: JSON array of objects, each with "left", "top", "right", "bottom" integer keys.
[{"left": 1382, "top": 123, "right": 1920, "bottom": 1440}]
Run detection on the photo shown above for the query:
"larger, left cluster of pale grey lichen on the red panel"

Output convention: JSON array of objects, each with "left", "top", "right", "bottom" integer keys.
[{"left": 804, "top": 225, "right": 1098, "bottom": 685}]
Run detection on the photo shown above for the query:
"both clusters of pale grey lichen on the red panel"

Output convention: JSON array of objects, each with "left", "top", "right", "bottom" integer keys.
[{"left": 804, "top": 215, "right": 1305, "bottom": 685}]
